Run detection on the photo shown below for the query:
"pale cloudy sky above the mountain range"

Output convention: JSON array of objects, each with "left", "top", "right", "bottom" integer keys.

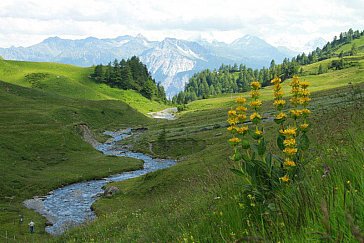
[{"left": 0, "top": 0, "right": 364, "bottom": 49}]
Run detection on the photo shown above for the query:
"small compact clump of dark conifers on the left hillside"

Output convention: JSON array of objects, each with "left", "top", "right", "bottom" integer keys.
[{"left": 91, "top": 56, "right": 167, "bottom": 102}]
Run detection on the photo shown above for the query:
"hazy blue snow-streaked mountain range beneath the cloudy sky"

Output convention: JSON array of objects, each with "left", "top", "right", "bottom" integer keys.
[{"left": 0, "top": 35, "right": 294, "bottom": 96}]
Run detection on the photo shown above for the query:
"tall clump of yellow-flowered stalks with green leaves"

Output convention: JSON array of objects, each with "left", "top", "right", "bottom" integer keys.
[{"left": 228, "top": 76, "right": 311, "bottom": 207}]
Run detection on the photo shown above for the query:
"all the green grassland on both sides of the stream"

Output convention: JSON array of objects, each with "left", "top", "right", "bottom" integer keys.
[{"left": 0, "top": 36, "right": 364, "bottom": 242}]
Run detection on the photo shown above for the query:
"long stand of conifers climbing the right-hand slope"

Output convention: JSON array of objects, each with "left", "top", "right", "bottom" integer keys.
[{"left": 172, "top": 29, "right": 364, "bottom": 104}]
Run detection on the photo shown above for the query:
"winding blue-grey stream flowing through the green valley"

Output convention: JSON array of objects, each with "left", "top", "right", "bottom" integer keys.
[{"left": 24, "top": 129, "right": 176, "bottom": 235}]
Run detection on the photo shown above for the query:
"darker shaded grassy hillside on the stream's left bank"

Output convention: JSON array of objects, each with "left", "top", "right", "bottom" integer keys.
[{"left": 0, "top": 82, "right": 152, "bottom": 241}]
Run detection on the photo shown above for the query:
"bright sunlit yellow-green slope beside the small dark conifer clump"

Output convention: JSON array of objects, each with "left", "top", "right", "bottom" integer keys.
[{"left": 0, "top": 60, "right": 167, "bottom": 114}]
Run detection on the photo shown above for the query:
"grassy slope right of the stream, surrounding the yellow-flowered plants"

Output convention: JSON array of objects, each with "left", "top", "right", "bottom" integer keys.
[{"left": 54, "top": 80, "right": 364, "bottom": 242}]
